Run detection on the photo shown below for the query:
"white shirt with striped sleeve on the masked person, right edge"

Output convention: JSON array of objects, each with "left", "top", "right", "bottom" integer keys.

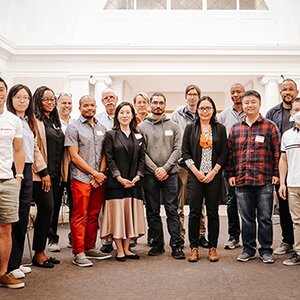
[{"left": 281, "top": 128, "right": 300, "bottom": 187}]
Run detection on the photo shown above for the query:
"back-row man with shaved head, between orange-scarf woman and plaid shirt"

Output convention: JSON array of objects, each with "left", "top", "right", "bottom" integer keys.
[{"left": 219, "top": 83, "right": 245, "bottom": 249}]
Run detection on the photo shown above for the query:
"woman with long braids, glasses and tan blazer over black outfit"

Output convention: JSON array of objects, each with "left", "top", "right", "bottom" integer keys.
[{"left": 32, "top": 86, "right": 66, "bottom": 268}]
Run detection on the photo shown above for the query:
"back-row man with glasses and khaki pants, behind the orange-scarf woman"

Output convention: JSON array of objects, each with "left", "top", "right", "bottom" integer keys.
[{"left": 171, "top": 84, "right": 208, "bottom": 248}]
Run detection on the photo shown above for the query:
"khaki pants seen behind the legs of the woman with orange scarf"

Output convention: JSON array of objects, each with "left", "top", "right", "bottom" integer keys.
[{"left": 178, "top": 167, "right": 206, "bottom": 239}]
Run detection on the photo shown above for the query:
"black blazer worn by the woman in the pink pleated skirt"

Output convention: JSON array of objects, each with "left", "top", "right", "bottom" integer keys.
[{"left": 104, "top": 129, "right": 145, "bottom": 188}]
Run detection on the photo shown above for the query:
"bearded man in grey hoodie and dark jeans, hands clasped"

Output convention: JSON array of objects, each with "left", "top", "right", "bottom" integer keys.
[{"left": 138, "top": 93, "right": 185, "bottom": 259}]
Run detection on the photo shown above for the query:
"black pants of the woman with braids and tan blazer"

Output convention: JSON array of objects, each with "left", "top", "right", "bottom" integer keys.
[{"left": 32, "top": 179, "right": 60, "bottom": 252}]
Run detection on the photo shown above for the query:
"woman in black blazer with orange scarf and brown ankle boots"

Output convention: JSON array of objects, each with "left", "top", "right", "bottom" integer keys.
[{"left": 182, "top": 96, "right": 228, "bottom": 262}]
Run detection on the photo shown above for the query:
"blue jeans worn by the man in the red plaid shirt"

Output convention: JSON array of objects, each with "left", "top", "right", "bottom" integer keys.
[{"left": 235, "top": 183, "right": 273, "bottom": 256}]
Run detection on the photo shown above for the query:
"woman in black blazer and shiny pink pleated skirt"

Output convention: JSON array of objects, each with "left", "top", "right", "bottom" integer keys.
[{"left": 101, "top": 102, "right": 145, "bottom": 261}]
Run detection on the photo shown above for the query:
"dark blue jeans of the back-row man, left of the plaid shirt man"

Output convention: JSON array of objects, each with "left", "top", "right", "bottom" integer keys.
[{"left": 224, "top": 172, "right": 241, "bottom": 241}]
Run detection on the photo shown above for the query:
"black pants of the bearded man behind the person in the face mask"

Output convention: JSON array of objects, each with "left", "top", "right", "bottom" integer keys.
[{"left": 275, "top": 185, "right": 294, "bottom": 245}]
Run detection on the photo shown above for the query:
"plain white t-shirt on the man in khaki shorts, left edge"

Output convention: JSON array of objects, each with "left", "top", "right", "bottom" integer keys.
[{"left": 0, "top": 111, "right": 23, "bottom": 179}]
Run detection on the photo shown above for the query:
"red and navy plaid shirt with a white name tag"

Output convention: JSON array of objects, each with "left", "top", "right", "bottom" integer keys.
[{"left": 226, "top": 115, "right": 280, "bottom": 186}]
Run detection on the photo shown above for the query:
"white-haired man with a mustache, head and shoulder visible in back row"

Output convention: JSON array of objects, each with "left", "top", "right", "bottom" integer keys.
[{"left": 96, "top": 88, "right": 118, "bottom": 130}]
